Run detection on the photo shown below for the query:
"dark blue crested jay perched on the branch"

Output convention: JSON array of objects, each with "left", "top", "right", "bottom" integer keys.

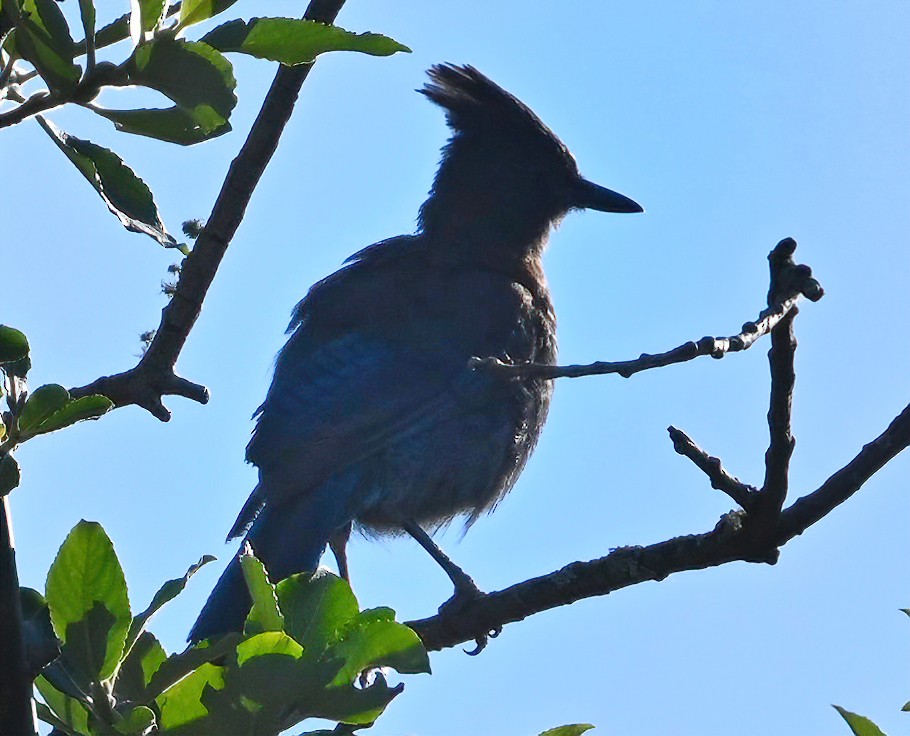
[{"left": 188, "top": 63, "right": 643, "bottom": 642}]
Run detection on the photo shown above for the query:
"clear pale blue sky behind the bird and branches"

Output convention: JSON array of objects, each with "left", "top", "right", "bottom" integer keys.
[{"left": 0, "top": 0, "right": 910, "bottom": 736}]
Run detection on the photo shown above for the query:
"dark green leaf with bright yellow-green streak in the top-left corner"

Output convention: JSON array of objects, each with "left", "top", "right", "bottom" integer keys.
[{"left": 16, "top": 0, "right": 81, "bottom": 96}]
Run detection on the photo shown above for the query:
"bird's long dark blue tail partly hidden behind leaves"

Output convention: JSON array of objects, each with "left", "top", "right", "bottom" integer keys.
[{"left": 187, "top": 494, "right": 350, "bottom": 643}]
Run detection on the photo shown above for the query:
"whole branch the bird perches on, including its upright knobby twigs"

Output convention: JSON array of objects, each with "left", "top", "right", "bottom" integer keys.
[{"left": 408, "top": 238, "right": 910, "bottom": 650}]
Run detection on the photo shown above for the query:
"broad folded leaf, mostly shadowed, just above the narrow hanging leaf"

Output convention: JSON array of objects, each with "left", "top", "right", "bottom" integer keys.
[{"left": 92, "top": 38, "right": 237, "bottom": 145}]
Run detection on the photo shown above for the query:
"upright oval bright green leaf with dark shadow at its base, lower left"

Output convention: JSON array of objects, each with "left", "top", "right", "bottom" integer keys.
[{"left": 45, "top": 520, "right": 132, "bottom": 680}]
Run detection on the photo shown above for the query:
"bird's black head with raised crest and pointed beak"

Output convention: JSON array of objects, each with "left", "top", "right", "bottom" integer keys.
[{"left": 419, "top": 64, "right": 642, "bottom": 250}]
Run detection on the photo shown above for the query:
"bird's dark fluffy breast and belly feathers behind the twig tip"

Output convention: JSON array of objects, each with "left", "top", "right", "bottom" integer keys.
[{"left": 356, "top": 274, "right": 556, "bottom": 532}]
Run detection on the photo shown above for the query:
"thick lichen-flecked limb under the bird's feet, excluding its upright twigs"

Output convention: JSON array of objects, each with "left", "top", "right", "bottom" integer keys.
[{"left": 408, "top": 406, "right": 910, "bottom": 650}]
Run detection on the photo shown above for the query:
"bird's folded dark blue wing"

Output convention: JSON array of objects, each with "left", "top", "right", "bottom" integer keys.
[{"left": 231, "top": 330, "right": 471, "bottom": 536}]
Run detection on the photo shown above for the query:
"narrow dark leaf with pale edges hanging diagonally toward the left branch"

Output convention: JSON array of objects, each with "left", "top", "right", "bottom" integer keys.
[{"left": 38, "top": 116, "right": 177, "bottom": 248}]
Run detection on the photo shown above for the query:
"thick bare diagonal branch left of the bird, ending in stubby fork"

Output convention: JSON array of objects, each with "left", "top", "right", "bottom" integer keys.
[{"left": 71, "top": 0, "right": 344, "bottom": 422}]
